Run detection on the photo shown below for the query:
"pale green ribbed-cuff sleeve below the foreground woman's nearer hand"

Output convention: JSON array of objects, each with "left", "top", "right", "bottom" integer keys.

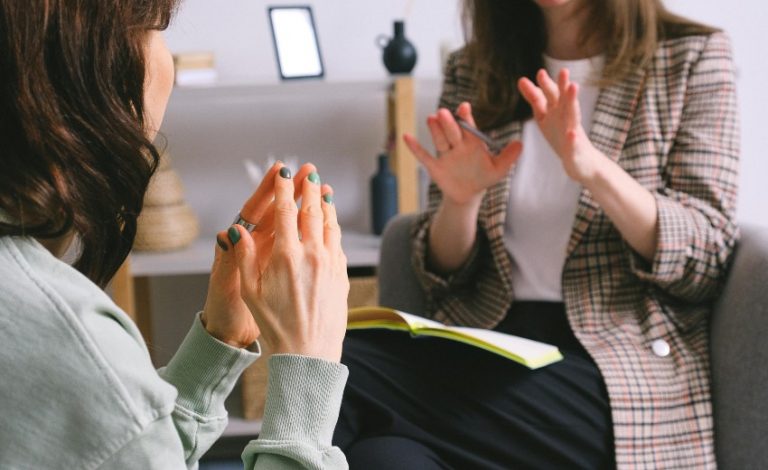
[{"left": 243, "top": 354, "right": 349, "bottom": 470}]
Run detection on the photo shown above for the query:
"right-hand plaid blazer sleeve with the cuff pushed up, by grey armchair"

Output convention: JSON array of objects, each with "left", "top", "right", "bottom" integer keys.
[{"left": 627, "top": 33, "right": 739, "bottom": 302}]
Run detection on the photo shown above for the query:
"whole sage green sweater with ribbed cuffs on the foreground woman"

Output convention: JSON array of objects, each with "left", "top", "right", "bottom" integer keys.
[{"left": 0, "top": 237, "right": 347, "bottom": 470}]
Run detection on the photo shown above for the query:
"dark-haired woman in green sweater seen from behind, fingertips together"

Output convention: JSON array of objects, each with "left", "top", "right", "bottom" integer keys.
[{"left": 0, "top": 0, "right": 349, "bottom": 470}]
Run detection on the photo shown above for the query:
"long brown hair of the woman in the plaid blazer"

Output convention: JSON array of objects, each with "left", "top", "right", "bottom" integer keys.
[{"left": 463, "top": 0, "right": 716, "bottom": 129}]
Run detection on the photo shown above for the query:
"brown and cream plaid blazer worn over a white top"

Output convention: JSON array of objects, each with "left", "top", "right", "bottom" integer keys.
[{"left": 413, "top": 33, "right": 739, "bottom": 469}]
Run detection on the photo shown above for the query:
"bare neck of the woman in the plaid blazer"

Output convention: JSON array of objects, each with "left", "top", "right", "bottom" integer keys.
[{"left": 544, "top": 1, "right": 602, "bottom": 60}]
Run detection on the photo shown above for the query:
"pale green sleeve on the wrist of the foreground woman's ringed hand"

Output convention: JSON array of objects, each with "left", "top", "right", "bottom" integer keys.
[{"left": 158, "top": 315, "right": 259, "bottom": 468}]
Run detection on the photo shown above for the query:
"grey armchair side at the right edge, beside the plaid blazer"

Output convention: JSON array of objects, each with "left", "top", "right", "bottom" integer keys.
[{"left": 710, "top": 226, "right": 768, "bottom": 470}]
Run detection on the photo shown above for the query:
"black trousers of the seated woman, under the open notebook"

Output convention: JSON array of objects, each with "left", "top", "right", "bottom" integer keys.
[{"left": 334, "top": 302, "right": 614, "bottom": 470}]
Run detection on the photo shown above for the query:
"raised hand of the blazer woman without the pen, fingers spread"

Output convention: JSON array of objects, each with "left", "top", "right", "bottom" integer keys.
[{"left": 518, "top": 69, "right": 600, "bottom": 184}]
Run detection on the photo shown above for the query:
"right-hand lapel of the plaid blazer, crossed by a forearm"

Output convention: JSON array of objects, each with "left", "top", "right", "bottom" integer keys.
[{"left": 567, "top": 68, "right": 647, "bottom": 255}]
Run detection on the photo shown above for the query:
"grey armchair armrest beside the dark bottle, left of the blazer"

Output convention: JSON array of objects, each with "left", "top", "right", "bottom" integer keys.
[{"left": 378, "top": 214, "right": 426, "bottom": 315}]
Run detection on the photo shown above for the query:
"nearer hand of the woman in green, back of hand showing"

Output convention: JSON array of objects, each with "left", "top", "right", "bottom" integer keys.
[{"left": 228, "top": 167, "right": 349, "bottom": 362}]
